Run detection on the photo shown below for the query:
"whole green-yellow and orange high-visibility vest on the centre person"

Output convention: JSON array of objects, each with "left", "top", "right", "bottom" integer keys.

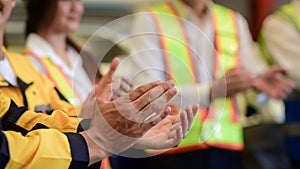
[{"left": 149, "top": 2, "right": 243, "bottom": 153}]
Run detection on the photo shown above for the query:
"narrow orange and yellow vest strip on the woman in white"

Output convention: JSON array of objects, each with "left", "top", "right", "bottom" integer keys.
[{"left": 23, "top": 50, "right": 82, "bottom": 106}]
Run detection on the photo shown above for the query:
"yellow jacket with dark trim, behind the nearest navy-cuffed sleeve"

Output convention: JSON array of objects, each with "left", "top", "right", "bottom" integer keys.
[{"left": 0, "top": 48, "right": 82, "bottom": 132}]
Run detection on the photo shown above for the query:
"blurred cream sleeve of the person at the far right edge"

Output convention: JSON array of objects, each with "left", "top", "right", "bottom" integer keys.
[{"left": 262, "top": 16, "right": 300, "bottom": 89}]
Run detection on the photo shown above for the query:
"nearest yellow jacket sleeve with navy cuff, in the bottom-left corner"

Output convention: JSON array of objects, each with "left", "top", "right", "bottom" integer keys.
[{"left": 0, "top": 129, "right": 89, "bottom": 169}]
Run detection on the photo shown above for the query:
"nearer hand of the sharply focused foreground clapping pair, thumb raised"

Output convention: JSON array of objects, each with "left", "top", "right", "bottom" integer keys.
[{"left": 84, "top": 59, "right": 176, "bottom": 153}]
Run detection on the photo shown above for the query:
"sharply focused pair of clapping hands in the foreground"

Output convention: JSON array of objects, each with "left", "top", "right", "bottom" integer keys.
[{"left": 81, "top": 58, "right": 198, "bottom": 164}]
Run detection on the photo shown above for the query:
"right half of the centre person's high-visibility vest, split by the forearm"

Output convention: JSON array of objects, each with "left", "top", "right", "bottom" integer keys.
[{"left": 201, "top": 5, "right": 243, "bottom": 150}]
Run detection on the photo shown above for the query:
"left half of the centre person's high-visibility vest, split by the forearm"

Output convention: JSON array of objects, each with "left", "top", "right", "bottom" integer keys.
[{"left": 149, "top": 2, "right": 206, "bottom": 154}]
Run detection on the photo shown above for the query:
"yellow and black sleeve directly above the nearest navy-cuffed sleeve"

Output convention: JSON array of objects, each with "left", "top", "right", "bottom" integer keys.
[{"left": 0, "top": 91, "right": 89, "bottom": 135}]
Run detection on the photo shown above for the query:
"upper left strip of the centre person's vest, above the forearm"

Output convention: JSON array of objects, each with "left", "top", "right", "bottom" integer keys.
[{"left": 149, "top": 2, "right": 199, "bottom": 85}]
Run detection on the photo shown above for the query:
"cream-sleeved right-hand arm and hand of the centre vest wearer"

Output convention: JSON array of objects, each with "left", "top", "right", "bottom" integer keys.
[{"left": 237, "top": 15, "right": 294, "bottom": 99}]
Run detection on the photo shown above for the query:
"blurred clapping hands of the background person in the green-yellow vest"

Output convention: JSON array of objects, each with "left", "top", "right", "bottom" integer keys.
[{"left": 211, "top": 65, "right": 296, "bottom": 100}]
